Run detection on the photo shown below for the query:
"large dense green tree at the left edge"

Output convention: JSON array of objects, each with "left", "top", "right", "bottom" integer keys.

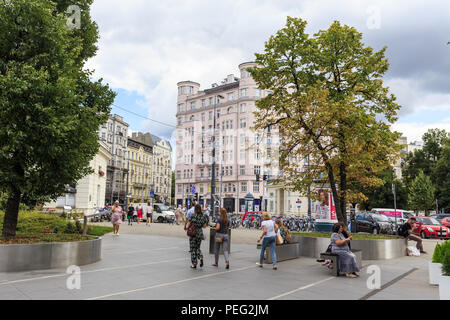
[{"left": 0, "top": 0, "right": 115, "bottom": 237}]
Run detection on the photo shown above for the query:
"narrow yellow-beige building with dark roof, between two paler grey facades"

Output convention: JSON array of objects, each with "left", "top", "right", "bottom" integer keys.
[{"left": 127, "top": 132, "right": 153, "bottom": 204}]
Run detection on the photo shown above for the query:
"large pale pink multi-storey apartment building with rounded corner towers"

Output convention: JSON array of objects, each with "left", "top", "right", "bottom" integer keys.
[{"left": 175, "top": 62, "right": 279, "bottom": 213}]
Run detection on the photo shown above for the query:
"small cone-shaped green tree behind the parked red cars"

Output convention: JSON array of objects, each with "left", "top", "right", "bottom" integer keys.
[{"left": 409, "top": 170, "right": 434, "bottom": 215}]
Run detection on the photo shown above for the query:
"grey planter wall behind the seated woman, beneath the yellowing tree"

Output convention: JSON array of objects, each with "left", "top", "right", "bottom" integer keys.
[{"left": 292, "top": 236, "right": 406, "bottom": 260}]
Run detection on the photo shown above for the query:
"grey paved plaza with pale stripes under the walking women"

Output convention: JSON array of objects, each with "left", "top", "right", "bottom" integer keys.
[{"left": 0, "top": 223, "right": 439, "bottom": 300}]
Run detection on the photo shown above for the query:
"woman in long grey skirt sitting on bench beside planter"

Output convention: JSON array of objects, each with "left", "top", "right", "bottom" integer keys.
[{"left": 331, "top": 222, "right": 360, "bottom": 278}]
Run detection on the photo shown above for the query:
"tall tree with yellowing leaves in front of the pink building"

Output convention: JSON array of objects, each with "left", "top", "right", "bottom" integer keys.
[{"left": 250, "top": 17, "right": 400, "bottom": 222}]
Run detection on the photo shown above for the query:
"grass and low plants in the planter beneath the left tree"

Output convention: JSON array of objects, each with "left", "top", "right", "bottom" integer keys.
[{"left": 0, "top": 211, "right": 113, "bottom": 244}]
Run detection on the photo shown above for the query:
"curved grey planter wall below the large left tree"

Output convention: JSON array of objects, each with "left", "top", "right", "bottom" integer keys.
[{"left": 0, "top": 237, "right": 102, "bottom": 272}]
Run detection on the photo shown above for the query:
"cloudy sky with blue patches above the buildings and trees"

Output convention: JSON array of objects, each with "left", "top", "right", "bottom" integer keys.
[{"left": 88, "top": 0, "right": 450, "bottom": 145}]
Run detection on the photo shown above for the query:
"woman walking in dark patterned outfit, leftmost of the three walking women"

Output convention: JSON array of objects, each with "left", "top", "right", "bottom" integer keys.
[{"left": 187, "top": 204, "right": 208, "bottom": 269}]
